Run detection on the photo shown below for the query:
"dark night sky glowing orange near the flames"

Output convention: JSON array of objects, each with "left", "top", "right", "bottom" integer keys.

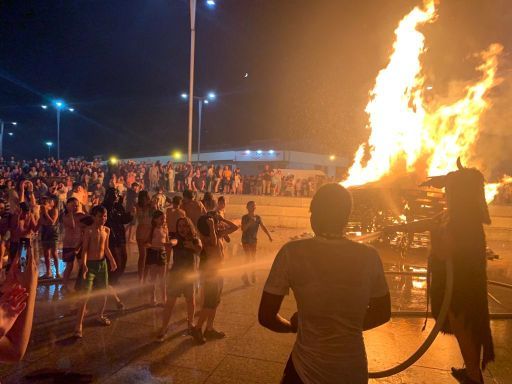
[{"left": 0, "top": 0, "right": 512, "bottom": 165}]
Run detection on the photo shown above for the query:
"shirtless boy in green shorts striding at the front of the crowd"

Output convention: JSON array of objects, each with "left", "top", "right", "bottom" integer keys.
[{"left": 75, "top": 205, "right": 117, "bottom": 338}]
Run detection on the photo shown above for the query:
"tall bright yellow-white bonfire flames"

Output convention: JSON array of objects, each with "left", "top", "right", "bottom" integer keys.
[{"left": 342, "top": 0, "right": 506, "bottom": 201}]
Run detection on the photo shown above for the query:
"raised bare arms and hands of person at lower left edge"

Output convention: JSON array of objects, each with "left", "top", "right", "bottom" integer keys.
[{"left": 0, "top": 244, "right": 38, "bottom": 363}]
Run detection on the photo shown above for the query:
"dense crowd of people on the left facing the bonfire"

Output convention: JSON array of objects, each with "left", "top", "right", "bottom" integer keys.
[{"left": 0, "top": 155, "right": 278, "bottom": 355}]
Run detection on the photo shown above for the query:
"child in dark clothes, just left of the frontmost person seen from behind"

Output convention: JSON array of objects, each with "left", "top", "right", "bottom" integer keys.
[{"left": 158, "top": 217, "right": 202, "bottom": 341}]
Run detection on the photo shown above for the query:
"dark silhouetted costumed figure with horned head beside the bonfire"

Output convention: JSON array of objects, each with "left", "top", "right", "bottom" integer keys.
[{"left": 394, "top": 159, "right": 494, "bottom": 384}]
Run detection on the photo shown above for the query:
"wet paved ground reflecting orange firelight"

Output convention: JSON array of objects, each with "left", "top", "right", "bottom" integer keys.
[{"left": 0, "top": 229, "right": 512, "bottom": 384}]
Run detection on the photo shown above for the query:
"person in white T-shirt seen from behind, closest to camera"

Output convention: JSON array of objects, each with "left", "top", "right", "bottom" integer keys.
[{"left": 258, "top": 184, "right": 391, "bottom": 384}]
